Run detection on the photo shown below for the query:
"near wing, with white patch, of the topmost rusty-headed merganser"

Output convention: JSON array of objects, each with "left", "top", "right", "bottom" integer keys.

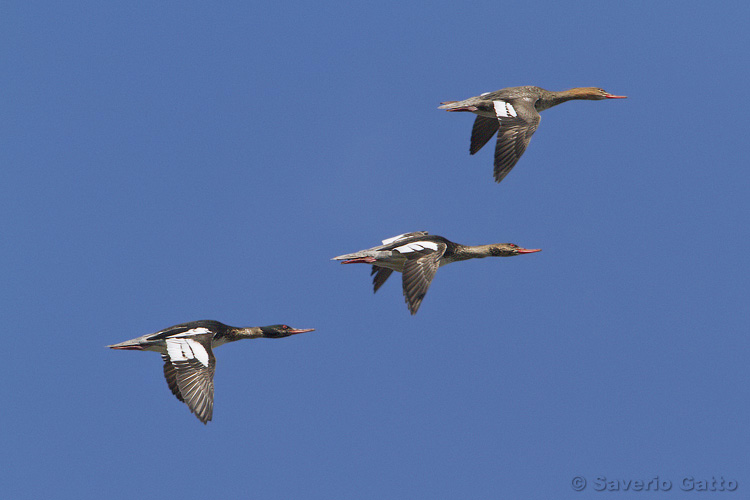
[{"left": 492, "top": 99, "right": 541, "bottom": 182}]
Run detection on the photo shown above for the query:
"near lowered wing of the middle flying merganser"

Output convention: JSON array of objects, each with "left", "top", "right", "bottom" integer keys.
[{"left": 394, "top": 241, "right": 447, "bottom": 314}]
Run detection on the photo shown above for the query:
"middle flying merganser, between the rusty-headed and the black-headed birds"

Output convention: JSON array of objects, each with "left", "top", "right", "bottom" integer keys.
[{"left": 331, "top": 231, "right": 541, "bottom": 314}]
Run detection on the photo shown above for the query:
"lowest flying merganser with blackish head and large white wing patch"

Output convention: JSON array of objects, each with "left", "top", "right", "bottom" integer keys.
[{"left": 107, "top": 320, "right": 314, "bottom": 424}]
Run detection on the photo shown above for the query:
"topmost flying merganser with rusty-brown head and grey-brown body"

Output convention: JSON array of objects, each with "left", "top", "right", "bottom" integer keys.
[{"left": 439, "top": 86, "right": 627, "bottom": 182}]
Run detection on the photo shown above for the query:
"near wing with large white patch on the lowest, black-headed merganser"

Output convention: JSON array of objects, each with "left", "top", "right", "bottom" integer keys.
[{"left": 162, "top": 333, "right": 216, "bottom": 424}]
